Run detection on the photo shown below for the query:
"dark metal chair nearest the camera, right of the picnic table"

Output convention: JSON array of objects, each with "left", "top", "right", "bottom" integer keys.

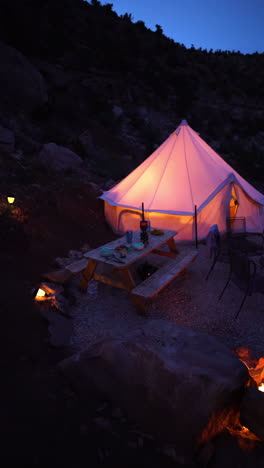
[{"left": 218, "top": 249, "right": 264, "bottom": 318}]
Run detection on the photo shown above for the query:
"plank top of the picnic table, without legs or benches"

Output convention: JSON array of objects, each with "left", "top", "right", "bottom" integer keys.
[{"left": 84, "top": 229, "right": 177, "bottom": 268}]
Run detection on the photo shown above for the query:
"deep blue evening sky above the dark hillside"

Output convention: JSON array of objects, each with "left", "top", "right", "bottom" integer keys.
[{"left": 108, "top": 0, "right": 264, "bottom": 54}]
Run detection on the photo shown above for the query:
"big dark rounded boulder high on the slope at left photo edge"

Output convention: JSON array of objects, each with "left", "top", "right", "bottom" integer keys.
[{"left": 0, "top": 43, "right": 48, "bottom": 112}]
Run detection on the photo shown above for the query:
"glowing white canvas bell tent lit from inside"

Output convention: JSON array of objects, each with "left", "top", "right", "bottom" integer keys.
[{"left": 101, "top": 120, "right": 264, "bottom": 240}]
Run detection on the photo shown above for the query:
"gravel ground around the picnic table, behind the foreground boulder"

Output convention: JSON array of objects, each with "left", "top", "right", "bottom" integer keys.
[{"left": 71, "top": 245, "right": 264, "bottom": 358}]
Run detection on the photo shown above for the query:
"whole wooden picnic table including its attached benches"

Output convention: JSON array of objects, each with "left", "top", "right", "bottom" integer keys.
[{"left": 66, "top": 229, "right": 198, "bottom": 313}]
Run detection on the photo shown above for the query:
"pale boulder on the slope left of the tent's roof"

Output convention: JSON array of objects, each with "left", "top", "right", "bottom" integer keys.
[{"left": 39, "top": 143, "right": 82, "bottom": 171}]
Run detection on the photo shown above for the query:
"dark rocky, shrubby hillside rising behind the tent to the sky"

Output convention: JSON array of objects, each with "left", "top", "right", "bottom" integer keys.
[{"left": 0, "top": 0, "right": 264, "bottom": 189}]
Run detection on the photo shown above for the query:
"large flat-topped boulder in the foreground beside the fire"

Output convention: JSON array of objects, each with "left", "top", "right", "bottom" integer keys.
[{"left": 60, "top": 320, "right": 249, "bottom": 460}]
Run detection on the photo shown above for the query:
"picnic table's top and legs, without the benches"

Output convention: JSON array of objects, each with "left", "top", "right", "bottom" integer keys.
[{"left": 80, "top": 229, "right": 178, "bottom": 292}]
